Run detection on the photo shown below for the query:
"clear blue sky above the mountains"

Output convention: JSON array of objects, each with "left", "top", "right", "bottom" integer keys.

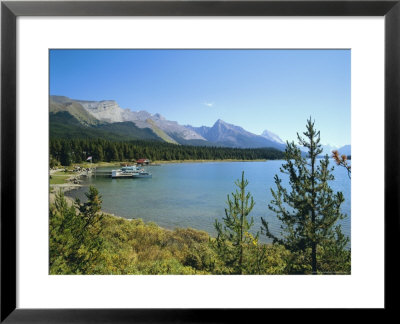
[{"left": 50, "top": 50, "right": 351, "bottom": 146}]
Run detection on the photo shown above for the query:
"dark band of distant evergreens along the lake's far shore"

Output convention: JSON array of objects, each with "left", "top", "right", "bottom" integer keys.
[{"left": 50, "top": 139, "right": 284, "bottom": 166}]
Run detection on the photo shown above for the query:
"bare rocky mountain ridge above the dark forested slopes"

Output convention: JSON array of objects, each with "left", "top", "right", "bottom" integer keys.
[{"left": 50, "top": 96, "right": 350, "bottom": 155}]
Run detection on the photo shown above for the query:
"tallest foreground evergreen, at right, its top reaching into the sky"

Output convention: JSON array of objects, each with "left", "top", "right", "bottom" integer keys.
[{"left": 261, "top": 118, "right": 348, "bottom": 274}]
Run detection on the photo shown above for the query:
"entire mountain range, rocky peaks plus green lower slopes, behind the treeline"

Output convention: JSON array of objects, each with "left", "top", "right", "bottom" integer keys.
[{"left": 50, "top": 96, "right": 350, "bottom": 155}]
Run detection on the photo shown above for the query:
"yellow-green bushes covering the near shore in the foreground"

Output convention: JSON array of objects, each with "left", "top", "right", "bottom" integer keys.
[{"left": 49, "top": 188, "right": 350, "bottom": 275}]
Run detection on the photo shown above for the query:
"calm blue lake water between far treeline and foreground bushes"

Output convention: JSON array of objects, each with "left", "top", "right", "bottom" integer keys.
[{"left": 68, "top": 161, "right": 351, "bottom": 242}]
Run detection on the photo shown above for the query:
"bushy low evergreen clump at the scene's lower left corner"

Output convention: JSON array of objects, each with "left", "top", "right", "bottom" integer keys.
[{"left": 50, "top": 187, "right": 104, "bottom": 274}]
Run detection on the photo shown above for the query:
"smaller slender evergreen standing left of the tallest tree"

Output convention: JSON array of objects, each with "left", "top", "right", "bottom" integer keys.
[{"left": 214, "top": 172, "right": 258, "bottom": 274}]
